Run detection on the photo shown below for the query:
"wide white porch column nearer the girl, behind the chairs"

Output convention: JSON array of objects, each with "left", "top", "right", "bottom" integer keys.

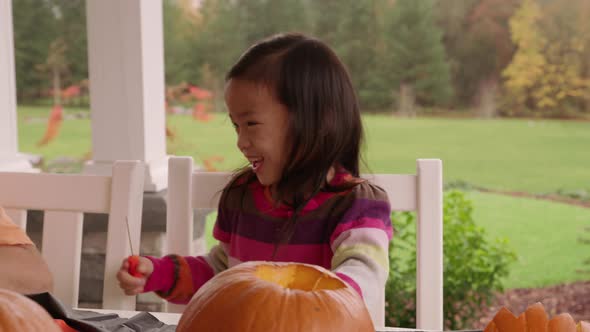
[{"left": 85, "top": 0, "right": 168, "bottom": 191}]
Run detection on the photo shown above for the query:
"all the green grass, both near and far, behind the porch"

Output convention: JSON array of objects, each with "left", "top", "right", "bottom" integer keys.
[{"left": 19, "top": 107, "right": 590, "bottom": 288}]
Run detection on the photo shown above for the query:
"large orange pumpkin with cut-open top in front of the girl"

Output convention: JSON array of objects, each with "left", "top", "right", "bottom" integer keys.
[{"left": 177, "top": 262, "right": 375, "bottom": 332}]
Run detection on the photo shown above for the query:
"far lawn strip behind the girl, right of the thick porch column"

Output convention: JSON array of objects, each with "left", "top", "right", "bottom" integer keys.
[{"left": 169, "top": 114, "right": 590, "bottom": 193}]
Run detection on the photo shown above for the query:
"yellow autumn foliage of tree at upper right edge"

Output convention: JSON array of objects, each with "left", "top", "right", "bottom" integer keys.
[{"left": 502, "top": 0, "right": 590, "bottom": 109}]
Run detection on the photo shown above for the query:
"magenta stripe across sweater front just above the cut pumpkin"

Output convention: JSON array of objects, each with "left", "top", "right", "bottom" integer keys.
[{"left": 229, "top": 235, "right": 333, "bottom": 269}]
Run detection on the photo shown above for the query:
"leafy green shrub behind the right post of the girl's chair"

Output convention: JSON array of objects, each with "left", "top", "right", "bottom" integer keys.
[{"left": 386, "top": 190, "right": 516, "bottom": 330}]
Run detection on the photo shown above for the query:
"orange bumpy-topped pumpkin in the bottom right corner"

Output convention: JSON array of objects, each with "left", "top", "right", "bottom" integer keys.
[{"left": 484, "top": 303, "right": 590, "bottom": 332}]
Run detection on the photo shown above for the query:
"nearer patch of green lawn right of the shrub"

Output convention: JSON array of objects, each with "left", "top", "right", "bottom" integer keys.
[{"left": 467, "top": 192, "right": 590, "bottom": 288}]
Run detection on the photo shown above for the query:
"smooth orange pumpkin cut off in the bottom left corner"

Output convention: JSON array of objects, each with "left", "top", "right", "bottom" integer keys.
[{"left": 0, "top": 289, "right": 61, "bottom": 332}]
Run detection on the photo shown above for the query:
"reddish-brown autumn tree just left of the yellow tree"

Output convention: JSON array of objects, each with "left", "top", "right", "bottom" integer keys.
[{"left": 437, "top": 0, "right": 518, "bottom": 117}]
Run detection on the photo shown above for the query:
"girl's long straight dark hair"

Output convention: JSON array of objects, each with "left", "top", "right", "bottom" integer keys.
[{"left": 225, "top": 33, "right": 363, "bottom": 252}]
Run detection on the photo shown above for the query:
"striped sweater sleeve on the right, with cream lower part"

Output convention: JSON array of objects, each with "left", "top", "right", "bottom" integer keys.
[{"left": 330, "top": 184, "right": 393, "bottom": 322}]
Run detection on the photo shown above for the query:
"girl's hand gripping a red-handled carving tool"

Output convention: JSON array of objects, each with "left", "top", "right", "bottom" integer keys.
[{"left": 117, "top": 256, "right": 154, "bottom": 295}]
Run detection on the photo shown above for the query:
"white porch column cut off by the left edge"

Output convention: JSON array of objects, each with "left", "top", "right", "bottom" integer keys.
[{"left": 0, "top": 0, "right": 37, "bottom": 172}]
